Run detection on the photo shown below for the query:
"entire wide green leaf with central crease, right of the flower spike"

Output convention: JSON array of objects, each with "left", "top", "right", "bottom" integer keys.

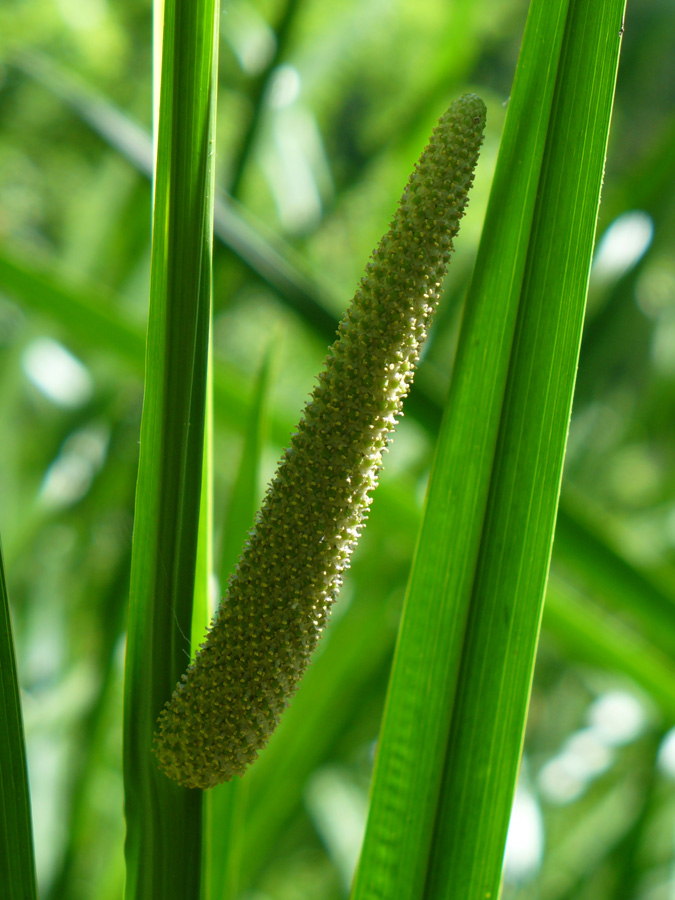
[{"left": 354, "top": 0, "right": 622, "bottom": 900}]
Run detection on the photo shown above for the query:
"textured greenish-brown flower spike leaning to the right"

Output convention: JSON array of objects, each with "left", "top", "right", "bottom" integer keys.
[{"left": 154, "top": 94, "right": 485, "bottom": 788}]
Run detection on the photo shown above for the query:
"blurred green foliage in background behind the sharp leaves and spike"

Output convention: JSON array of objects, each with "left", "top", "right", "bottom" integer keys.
[{"left": 0, "top": 0, "right": 675, "bottom": 900}]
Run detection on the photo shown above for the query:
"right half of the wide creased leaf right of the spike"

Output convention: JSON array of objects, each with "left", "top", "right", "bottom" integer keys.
[{"left": 425, "top": 0, "right": 625, "bottom": 900}]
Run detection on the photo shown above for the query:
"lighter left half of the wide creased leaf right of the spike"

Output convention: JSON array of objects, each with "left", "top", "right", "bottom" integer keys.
[{"left": 353, "top": 0, "right": 567, "bottom": 900}]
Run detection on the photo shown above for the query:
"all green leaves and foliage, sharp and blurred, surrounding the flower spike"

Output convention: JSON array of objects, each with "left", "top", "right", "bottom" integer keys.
[{"left": 0, "top": 0, "right": 675, "bottom": 900}]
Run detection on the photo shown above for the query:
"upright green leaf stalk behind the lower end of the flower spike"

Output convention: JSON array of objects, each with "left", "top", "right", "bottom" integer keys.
[{"left": 124, "top": 0, "right": 217, "bottom": 900}]
